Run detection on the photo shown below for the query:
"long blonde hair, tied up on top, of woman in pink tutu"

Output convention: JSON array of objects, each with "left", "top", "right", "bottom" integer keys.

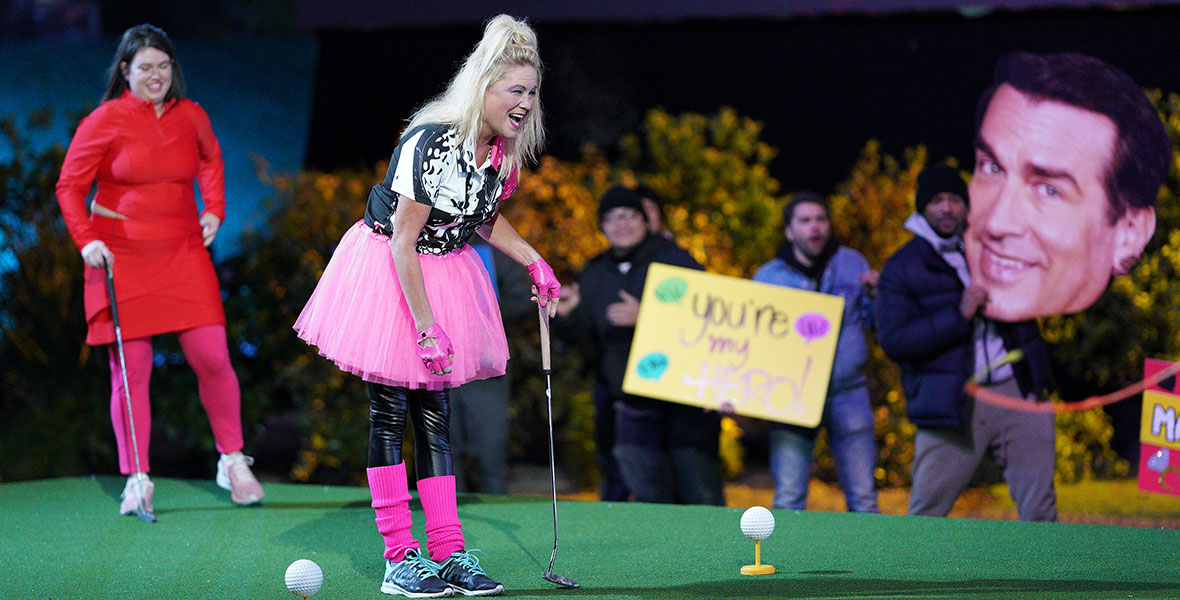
[{"left": 402, "top": 14, "right": 545, "bottom": 181}]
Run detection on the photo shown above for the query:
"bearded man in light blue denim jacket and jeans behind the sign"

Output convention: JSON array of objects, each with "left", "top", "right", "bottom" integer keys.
[{"left": 754, "top": 193, "right": 880, "bottom": 513}]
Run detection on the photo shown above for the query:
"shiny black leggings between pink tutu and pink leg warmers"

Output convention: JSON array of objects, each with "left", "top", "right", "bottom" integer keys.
[{"left": 366, "top": 381, "right": 453, "bottom": 480}]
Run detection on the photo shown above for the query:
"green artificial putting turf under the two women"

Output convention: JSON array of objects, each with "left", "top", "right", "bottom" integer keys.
[{"left": 0, "top": 477, "right": 1180, "bottom": 600}]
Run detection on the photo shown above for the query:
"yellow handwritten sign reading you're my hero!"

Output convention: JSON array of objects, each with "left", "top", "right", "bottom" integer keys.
[{"left": 623, "top": 265, "right": 844, "bottom": 426}]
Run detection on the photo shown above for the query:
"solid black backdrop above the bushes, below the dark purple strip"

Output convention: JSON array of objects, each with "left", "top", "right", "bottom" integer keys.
[{"left": 307, "top": 7, "right": 1180, "bottom": 191}]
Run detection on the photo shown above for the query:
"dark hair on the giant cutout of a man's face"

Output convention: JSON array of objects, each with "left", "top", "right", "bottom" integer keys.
[{"left": 975, "top": 52, "right": 1172, "bottom": 223}]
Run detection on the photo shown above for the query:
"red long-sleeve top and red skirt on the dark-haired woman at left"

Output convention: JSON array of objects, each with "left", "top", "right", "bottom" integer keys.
[{"left": 57, "top": 91, "right": 225, "bottom": 345}]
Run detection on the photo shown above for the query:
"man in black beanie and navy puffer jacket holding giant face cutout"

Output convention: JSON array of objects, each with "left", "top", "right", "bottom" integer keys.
[{"left": 876, "top": 165, "right": 1057, "bottom": 521}]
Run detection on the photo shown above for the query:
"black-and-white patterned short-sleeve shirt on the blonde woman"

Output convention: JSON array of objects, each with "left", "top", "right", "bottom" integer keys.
[{"left": 365, "top": 124, "right": 504, "bottom": 254}]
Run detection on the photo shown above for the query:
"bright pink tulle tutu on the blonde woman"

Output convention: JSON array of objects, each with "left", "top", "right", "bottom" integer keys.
[{"left": 295, "top": 221, "right": 509, "bottom": 390}]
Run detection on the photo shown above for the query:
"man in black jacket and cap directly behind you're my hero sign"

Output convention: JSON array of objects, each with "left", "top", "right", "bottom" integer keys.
[{"left": 553, "top": 185, "right": 725, "bottom": 506}]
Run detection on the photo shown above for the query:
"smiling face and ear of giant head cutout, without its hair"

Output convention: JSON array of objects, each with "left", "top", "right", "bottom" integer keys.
[{"left": 964, "top": 84, "right": 1155, "bottom": 321}]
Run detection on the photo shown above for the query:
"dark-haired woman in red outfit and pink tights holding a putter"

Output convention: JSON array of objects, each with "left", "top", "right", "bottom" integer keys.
[{"left": 57, "top": 25, "right": 263, "bottom": 514}]
